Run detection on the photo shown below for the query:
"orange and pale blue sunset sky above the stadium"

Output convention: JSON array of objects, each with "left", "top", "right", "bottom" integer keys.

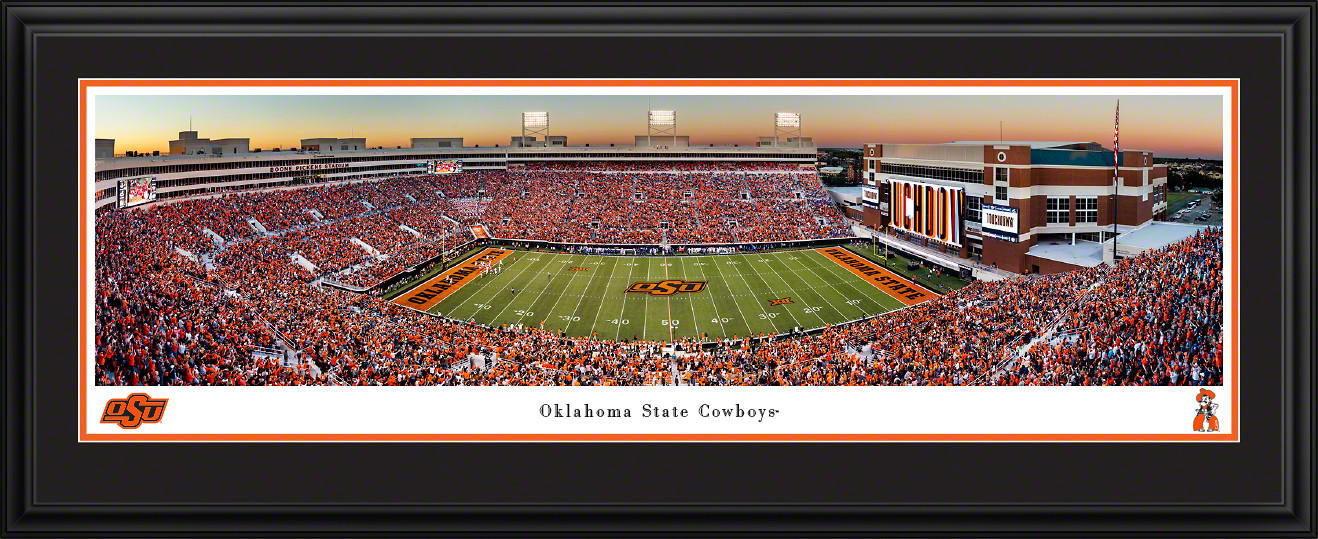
[{"left": 95, "top": 95, "right": 1223, "bottom": 159}]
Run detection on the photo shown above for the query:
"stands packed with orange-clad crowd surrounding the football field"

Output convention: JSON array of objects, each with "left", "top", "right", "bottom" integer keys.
[{"left": 95, "top": 156, "right": 1223, "bottom": 385}]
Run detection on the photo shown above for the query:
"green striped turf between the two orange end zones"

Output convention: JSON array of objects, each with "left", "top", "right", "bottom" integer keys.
[{"left": 430, "top": 250, "right": 903, "bottom": 341}]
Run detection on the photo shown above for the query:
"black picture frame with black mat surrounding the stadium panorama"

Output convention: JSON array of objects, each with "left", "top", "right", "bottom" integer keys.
[{"left": 0, "top": 3, "right": 1315, "bottom": 536}]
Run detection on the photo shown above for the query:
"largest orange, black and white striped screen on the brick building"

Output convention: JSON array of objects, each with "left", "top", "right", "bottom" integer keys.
[{"left": 888, "top": 179, "right": 966, "bottom": 246}]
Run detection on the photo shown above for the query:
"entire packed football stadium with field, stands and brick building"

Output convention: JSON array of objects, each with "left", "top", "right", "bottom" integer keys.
[{"left": 94, "top": 111, "right": 1223, "bottom": 386}]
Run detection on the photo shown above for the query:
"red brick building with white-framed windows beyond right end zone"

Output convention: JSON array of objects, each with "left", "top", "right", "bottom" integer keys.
[{"left": 862, "top": 141, "right": 1166, "bottom": 273}]
